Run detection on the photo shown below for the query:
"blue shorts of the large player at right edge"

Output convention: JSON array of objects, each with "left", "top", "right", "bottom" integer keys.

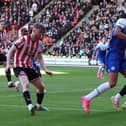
[{"left": 105, "top": 52, "right": 126, "bottom": 73}]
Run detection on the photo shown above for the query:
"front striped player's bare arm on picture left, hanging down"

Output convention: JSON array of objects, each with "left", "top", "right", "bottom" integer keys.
[{"left": 5, "top": 45, "right": 17, "bottom": 71}]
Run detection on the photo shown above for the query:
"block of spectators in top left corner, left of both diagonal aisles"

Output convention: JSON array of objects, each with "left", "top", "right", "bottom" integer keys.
[{"left": 0, "top": 0, "right": 51, "bottom": 27}]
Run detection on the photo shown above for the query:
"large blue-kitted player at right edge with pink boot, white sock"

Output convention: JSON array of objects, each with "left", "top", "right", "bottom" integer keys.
[{"left": 81, "top": 11, "right": 126, "bottom": 113}]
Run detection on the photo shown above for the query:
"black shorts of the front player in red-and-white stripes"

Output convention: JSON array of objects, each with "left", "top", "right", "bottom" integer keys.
[{"left": 14, "top": 67, "right": 40, "bottom": 81}]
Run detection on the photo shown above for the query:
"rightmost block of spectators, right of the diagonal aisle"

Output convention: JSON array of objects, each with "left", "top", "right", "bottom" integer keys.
[{"left": 48, "top": 1, "right": 126, "bottom": 58}]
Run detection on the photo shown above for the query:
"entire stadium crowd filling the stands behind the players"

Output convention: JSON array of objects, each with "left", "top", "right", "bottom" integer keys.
[{"left": 0, "top": 0, "right": 126, "bottom": 58}]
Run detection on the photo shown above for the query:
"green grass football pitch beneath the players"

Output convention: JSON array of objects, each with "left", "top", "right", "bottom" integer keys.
[{"left": 0, "top": 66, "right": 126, "bottom": 126}]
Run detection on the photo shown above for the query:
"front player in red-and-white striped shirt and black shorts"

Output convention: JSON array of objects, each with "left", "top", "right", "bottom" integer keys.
[{"left": 6, "top": 23, "right": 53, "bottom": 115}]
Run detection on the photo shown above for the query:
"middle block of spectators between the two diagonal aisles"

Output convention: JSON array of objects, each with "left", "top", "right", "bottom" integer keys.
[{"left": 34, "top": 0, "right": 92, "bottom": 49}]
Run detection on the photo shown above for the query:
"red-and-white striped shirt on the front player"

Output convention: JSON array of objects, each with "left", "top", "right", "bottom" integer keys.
[{"left": 13, "top": 35, "right": 42, "bottom": 69}]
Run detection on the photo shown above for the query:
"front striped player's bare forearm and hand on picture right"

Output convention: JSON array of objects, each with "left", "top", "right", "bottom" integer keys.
[{"left": 38, "top": 54, "right": 53, "bottom": 76}]
